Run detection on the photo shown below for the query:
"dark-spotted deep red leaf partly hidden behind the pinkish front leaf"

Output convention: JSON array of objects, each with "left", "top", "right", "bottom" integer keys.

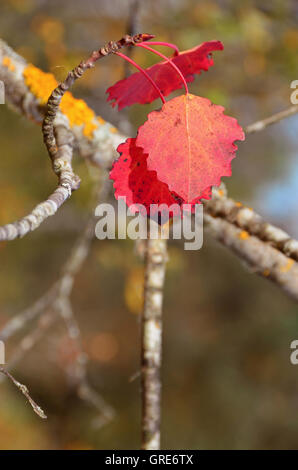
[{"left": 110, "top": 139, "right": 211, "bottom": 222}]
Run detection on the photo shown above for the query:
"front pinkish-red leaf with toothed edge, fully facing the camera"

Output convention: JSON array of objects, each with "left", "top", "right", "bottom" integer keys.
[{"left": 136, "top": 94, "right": 245, "bottom": 203}]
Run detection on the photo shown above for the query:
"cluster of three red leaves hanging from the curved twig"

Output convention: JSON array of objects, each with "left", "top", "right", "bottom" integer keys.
[{"left": 108, "top": 41, "right": 244, "bottom": 220}]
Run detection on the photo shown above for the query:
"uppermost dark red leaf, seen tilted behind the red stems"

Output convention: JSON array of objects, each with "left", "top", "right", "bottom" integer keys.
[{"left": 106, "top": 41, "right": 223, "bottom": 110}]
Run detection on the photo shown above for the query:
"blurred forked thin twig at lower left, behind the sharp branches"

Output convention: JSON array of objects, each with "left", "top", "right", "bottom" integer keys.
[{"left": 0, "top": 175, "right": 115, "bottom": 427}]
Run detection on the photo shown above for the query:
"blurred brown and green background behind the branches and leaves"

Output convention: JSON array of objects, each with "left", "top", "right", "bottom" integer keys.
[{"left": 0, "top": 0, "right": 298, "bottom": 449}]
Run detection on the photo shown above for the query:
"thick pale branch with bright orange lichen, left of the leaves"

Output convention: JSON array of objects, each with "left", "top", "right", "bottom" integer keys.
[{"left": 0, "top": 39, "right": 124, "bottom": 171}]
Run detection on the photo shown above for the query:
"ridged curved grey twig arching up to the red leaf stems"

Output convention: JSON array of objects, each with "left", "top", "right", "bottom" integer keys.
[{"left": 0, "top": 34, "right": 153, "bottom": 241}]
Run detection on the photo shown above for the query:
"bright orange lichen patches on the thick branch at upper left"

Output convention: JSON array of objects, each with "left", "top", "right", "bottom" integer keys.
[{"left": 23, "top": 64, "right": 112, "bottom": 138}]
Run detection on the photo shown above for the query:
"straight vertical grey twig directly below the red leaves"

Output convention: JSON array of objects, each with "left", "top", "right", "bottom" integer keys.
[{"left": 141, "top": 238, "right": 167, "bottom": 450}]
